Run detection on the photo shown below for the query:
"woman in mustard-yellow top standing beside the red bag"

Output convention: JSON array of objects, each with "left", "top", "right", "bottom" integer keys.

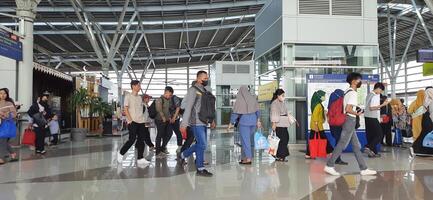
[{"left": 305, "top": 90, "right": 333, "bottom": 159}]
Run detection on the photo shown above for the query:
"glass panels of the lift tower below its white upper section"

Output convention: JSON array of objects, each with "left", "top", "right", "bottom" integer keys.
[{"left": 256, "top": 44, "right": 378, "bottom": 143}]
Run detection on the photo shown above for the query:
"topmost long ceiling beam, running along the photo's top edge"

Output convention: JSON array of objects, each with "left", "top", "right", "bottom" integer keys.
[{"left": 0, "top": 0, "right": 267, "bottom": 13}]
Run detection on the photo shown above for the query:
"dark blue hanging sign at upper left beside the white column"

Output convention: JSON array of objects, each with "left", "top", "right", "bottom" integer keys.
[{"left": 0, "top": 29, "right": 23, "bottom": 61}]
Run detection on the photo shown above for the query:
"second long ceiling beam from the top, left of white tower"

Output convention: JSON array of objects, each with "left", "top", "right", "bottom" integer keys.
[{"left": 34, "top": 20, "right": 256, "bottom": 35}]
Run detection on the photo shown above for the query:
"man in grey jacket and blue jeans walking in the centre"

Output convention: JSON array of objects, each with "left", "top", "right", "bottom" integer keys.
[{"left": 179, "top": 71, "right": 215, "bottom": 177}]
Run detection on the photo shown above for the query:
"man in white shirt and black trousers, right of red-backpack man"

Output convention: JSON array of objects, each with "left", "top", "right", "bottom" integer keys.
[{"left": 364, "top": 83, "right": 389, "bottom": 158}]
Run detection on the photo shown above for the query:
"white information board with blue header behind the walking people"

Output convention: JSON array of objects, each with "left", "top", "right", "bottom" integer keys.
[{"left": 307, "top": 74, "right": 380, "bottom": 130}]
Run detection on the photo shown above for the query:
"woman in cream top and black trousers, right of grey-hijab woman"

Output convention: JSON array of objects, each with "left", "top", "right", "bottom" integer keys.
[{"left": 271, "top": 89, "right": 290, "bottom": 162}]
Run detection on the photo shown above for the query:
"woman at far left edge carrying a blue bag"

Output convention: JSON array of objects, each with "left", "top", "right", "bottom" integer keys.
[{"left": 0, "top": 88, "right": 17, "bottom": 165}]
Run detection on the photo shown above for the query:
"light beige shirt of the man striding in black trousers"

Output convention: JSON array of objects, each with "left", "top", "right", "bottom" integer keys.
[{"left": 124, "top": 94, "right": 146, "bottom": 124}]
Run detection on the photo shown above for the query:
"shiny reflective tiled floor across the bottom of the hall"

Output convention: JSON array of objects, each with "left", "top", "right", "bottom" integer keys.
[{"left": 0, "top": 129, "right": 433, "bottom": 200}]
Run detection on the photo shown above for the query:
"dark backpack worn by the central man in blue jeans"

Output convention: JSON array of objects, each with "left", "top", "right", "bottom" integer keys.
[{"left": 193, "top": 86, "right": 216, "bottom": 124}]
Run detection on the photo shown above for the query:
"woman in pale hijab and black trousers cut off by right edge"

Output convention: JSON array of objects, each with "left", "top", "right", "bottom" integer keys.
[{"left": 410, "top": 88, "right": 433, "bottom": 156}]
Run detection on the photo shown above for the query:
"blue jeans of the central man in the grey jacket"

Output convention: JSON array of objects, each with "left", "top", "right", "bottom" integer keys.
[{"left": 182, "top": 126, "right": 207, "bottom": 170}]
